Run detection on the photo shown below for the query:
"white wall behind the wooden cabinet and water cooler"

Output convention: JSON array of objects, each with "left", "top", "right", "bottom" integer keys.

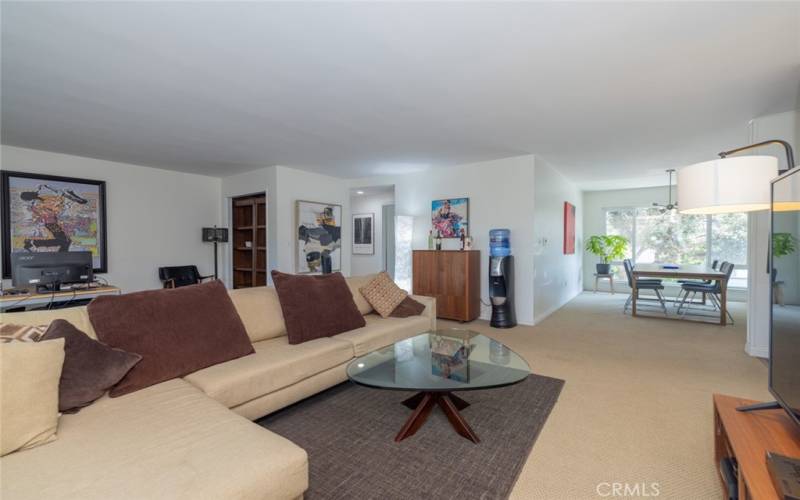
[{"left": 351, "top": 155, "right": 535, "bottom": 324}]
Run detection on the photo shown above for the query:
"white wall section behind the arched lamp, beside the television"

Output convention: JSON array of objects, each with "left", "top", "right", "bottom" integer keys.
[{"left": 744, "top": 110, "right": 800, "bottom": 358}]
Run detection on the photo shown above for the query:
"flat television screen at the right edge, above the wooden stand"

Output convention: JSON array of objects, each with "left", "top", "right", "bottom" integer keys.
[{"left": 769, "top": 168, "right": 800, "bottom": 425}]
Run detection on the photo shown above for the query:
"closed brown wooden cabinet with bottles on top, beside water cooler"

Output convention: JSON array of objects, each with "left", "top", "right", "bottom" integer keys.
[{"left": 412, "top": 250, "right": 481, "bottom": 321}]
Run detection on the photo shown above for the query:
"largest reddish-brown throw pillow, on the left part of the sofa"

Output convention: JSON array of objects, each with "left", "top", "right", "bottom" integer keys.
[{"left": 88, "top": 281, "right": 254, "bottom": 397}]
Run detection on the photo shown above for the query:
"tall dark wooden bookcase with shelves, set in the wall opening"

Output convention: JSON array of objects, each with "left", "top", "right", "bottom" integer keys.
[{"left": 231, "top": 194, "right": 267, "bottom": 288}]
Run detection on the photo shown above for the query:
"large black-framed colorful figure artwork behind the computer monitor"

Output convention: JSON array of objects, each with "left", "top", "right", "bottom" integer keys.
[{"left": 0, "top": 171, "right": 108, "bottom": 278}]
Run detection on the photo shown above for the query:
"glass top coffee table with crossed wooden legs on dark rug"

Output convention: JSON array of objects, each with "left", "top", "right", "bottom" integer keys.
[{"left": 347, "top": 329, "right": 531, "bottom": 443}]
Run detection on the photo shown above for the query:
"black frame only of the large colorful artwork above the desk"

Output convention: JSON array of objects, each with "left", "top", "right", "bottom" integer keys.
[{"left": 0, "top": 170, "right": 108, "bottom": 279}]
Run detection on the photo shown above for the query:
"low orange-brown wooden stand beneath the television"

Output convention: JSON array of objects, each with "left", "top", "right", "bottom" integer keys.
[{"left": 714, "top": 394, "right": 800, "bottom": 500}]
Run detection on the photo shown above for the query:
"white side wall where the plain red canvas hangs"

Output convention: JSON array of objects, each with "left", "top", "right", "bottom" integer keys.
[{"left": 533, "top": 156, "right": 583, "bottom": 323}]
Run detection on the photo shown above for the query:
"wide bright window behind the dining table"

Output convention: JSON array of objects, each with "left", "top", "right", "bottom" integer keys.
[{"left": 605, "top": 207, "right": 747, "bottom": 288}]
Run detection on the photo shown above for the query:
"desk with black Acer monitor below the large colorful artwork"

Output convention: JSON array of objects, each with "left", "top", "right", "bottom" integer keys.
[{"left": 0, "top": 252, "right": 122, "bottom": 312}]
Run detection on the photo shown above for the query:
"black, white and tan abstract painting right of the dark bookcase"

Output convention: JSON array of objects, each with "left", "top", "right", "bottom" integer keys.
[{"left": 295, "top": 200, "right": 342, "bottom": 273}]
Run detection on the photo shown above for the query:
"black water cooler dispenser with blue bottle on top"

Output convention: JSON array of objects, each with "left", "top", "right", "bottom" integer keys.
[{"left": 489, "top": 229, "right": 517, "bottom": 328}]
